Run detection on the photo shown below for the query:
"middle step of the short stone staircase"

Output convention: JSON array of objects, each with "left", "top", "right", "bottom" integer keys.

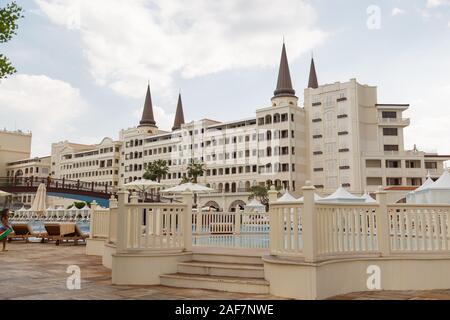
[{"left": 178, "top": 261, "right": 264, "bottom": 279}]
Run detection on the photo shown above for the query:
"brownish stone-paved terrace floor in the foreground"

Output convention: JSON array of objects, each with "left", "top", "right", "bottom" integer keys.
[{"left": 0, "top": 242, "right": 450, "bottom": 300}]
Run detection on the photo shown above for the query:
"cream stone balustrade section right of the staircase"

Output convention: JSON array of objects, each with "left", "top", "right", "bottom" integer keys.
[{"left": 269, "top": 182, "right": 450, "bottom": 262}]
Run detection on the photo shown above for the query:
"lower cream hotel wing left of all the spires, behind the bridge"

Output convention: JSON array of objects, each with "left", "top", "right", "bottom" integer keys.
[{"left": 51, "top": 138, "right": 121, "bottom": 187}]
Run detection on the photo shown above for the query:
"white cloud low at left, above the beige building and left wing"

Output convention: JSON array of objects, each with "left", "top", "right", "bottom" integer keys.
[{"left": 0, "top": 74, "right": 87, "bottom": 155}]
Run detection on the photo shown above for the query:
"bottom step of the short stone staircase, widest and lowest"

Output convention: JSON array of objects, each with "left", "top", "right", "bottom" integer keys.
[{"left": 160, "top": 273, "right": 269, "bottom": 294}]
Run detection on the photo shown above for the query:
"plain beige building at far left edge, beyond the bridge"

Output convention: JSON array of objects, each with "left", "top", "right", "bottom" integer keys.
[{"left": 0, "top": 130, "right": 32, "bottom": 177}]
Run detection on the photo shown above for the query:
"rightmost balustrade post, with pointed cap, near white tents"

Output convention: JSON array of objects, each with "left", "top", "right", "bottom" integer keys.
[{"left": 375, "top": 187, "right": 390, "bottom": 257}]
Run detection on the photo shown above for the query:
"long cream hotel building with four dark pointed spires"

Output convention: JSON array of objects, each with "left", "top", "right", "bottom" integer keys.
[{"left": 41, "top": 45, "right": 450, "bottom": 210}]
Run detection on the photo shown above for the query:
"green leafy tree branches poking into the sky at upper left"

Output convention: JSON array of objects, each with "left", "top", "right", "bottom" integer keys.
[{"left": 0, "top": 1, "right": 23, "bottom": 80}]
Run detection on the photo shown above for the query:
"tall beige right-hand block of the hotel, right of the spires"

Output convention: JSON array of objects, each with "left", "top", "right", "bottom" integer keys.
[{"left": 305, "top": 79, "right": 448, "bottom": 194}]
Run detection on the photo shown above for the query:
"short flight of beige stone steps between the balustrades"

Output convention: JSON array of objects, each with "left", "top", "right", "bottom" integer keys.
[{"left": 160, "top": 253, "right": 269, "bottom": 294}]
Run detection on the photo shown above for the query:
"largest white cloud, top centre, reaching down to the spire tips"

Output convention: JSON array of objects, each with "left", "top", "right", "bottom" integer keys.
[{"left": 35, "top": 0, "right": 326, "bottom": 98}]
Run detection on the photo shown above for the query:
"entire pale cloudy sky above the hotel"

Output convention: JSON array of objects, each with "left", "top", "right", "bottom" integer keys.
[{"left": 0, "top": 0, "right": 450, "bottom": 156}]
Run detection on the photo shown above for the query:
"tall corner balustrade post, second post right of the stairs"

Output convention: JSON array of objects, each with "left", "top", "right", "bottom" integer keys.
[{"left": 302, "top": 181, "right": 318, "bottom": 262}]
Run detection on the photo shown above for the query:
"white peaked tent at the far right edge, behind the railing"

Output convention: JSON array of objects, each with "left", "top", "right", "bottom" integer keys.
[{"left": 406, "top": 169, "right": 450, "bottom": 204}]
